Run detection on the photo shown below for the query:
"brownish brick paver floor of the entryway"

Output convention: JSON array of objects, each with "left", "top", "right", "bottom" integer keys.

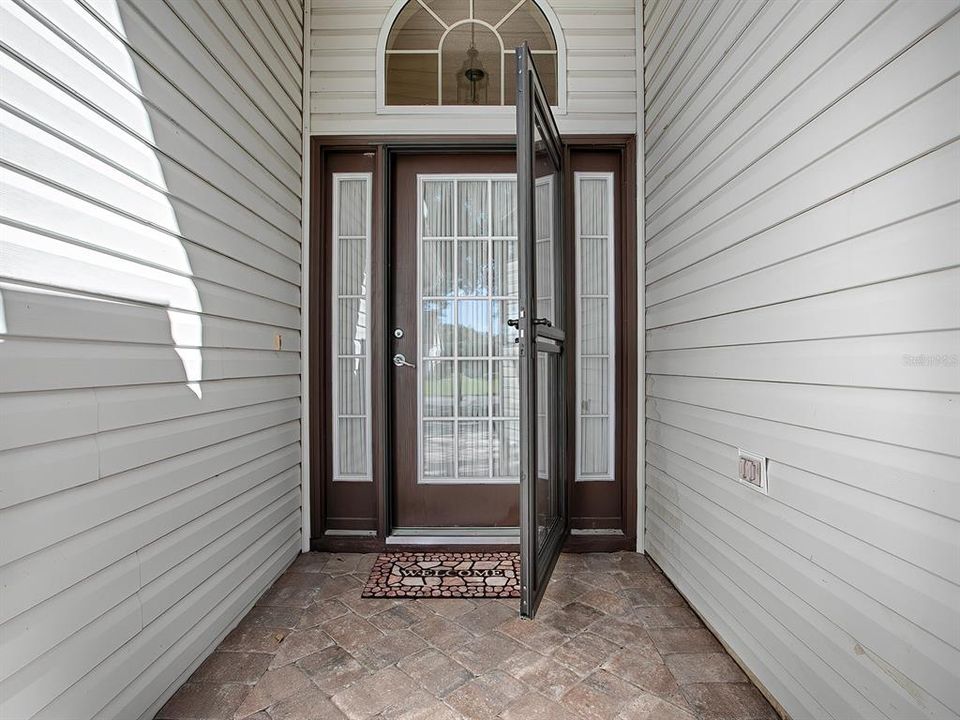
[{"left": 157, "top": 553, "right": 777, "bottom": 720}]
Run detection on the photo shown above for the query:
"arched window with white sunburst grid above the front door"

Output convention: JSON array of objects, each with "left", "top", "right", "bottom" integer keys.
[{"left": 384, "top": 0, "right": 558, "bottom": 105}]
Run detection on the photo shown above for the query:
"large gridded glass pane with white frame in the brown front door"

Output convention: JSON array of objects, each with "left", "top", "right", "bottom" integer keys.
[{"left": 417, "top": 174, "right": 520, "bottom": 483}]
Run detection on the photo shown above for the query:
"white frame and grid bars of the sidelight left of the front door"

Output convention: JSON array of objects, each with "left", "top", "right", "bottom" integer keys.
[{"left": 330, "top": 173, "right": 373, "bottom": 482}]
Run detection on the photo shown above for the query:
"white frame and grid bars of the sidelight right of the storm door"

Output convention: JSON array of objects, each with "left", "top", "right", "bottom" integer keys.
[{"left": 573, "top": 172, "right": 616, "bottom": 482}]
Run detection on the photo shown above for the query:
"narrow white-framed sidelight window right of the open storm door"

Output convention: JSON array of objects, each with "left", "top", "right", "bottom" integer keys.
[{"left": 574, "top": 173, "right": 615, "bottom": 481}]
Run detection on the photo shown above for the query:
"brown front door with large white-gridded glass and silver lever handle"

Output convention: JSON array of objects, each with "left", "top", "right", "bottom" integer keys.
[{"left": 388, "top": 153, "right": 520, "bottom": 528}]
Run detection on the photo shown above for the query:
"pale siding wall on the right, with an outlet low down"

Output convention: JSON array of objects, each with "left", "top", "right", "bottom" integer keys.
[{"left": 644, "top": 0, "right": 960, "bottom": 720}]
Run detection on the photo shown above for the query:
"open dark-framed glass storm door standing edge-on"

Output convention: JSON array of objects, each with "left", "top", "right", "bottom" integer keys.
[{"left": 511, "top": 43, "right": 569, "bottom": 617}]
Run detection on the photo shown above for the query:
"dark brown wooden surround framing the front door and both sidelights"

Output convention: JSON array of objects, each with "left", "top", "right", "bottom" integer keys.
[{"left": 309, "top": 135, "right": 641, "bottom": 552}]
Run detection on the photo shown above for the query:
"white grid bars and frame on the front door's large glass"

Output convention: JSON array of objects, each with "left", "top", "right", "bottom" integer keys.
[{"left": 416, "top": 173, "right": 520, "bottom": 485}]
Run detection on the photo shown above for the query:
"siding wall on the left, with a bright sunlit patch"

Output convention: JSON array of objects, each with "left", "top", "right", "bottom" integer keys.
[{"left": 0, "top": 0, "right": 303, "bottom": 718}]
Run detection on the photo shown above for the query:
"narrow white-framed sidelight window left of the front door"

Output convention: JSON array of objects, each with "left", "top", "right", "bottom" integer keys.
[{"left": 330, "top": 173, "right": 372, "bottom": 482}]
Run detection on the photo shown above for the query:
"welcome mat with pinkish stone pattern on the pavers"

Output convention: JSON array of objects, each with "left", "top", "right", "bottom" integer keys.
[{"left": 361, "top": 552, "right": 520, "bottom": 598}]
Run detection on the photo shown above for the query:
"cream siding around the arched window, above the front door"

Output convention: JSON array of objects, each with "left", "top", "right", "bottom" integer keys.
[{"left": 309, "top": 0, "right": 637, "bottom": 135}]
